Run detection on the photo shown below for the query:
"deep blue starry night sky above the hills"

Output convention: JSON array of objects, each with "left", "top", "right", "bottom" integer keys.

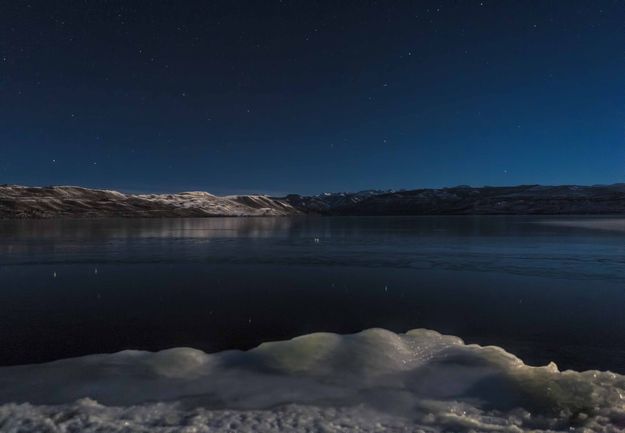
[{"left": 0, "top": 0, "right": 625, "bottom": 194}]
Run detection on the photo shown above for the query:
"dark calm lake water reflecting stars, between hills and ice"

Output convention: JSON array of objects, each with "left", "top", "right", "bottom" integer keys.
[{"left": 0, "top": 216, "right": 625, "bottom": 373}]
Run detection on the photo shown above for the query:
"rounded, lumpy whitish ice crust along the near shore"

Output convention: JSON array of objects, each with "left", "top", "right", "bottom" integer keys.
[{"left": 0, "top": 329, "right": 625, "bottom": 432}]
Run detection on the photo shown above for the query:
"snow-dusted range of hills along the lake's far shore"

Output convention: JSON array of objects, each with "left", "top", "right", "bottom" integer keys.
[{"left": 0, "top": 184, "right": 625, "bottom": 218}]
